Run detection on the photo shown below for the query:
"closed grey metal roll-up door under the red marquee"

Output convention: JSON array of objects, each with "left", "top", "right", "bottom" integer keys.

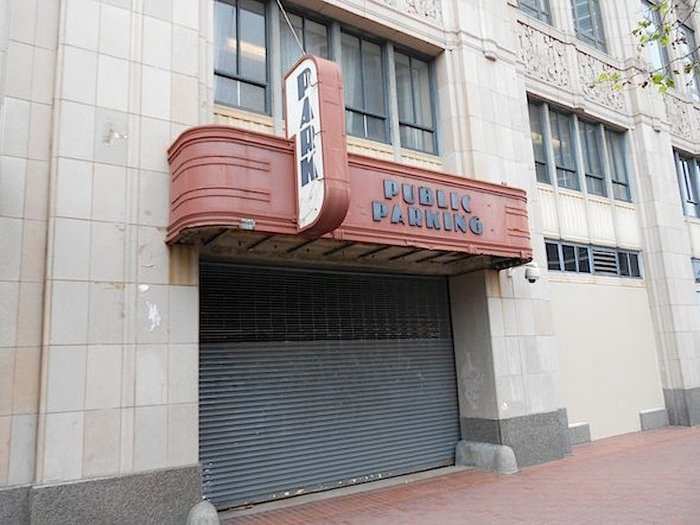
[{"left": 199, "top": 262, "right": 459, "bottom": 508}]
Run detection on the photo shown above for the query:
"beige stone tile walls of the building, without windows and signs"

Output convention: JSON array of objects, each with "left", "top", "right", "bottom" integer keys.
[{"left": 0, "top": 0, "right": 700, "bottom": 516}]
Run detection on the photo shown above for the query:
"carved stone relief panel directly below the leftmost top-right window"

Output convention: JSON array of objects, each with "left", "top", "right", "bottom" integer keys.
[{"left": 518, "top": 22, "right": 571, "bottom": 88}]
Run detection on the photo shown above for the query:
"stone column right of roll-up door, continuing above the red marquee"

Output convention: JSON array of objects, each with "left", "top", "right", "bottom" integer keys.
[{"left": 438, "top": 0, "right": 569, "bottom": 466}]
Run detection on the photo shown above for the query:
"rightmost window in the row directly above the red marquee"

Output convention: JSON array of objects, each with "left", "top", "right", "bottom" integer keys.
[{"left": 394, "top": 53, "right": 435, "bottom": 153}]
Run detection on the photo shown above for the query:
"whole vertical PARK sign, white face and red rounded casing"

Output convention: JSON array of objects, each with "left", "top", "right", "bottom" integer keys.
[{"left": 284, "top": 55, "right": 350, "bottom": 238}]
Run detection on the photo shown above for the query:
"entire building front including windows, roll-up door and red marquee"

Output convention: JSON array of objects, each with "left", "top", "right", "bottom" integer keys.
[{"left": 0, "top": 0, "right": 700, "bottom": 523}]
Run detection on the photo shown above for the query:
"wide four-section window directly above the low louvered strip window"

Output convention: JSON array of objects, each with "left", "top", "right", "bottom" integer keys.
[{"left": 528, "top": 101, "right": 632, "bottom": 202}]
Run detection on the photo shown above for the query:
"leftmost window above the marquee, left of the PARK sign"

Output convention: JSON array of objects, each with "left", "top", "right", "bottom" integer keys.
[{"left": 214, "top": 0, "right": 267, "bottom": 113}]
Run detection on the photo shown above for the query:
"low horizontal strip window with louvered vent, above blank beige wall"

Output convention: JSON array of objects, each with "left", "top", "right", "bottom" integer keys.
[{"left": 545, "top": 240, "right": 642, "bottom": 278}]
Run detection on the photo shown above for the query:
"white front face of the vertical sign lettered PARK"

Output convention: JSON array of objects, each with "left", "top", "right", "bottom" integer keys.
[{"left": 285, "top": 58, "right": 326, "bottom": 230}]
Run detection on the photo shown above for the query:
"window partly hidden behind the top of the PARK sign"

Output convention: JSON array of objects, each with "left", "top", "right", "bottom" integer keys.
[{"left": 280, "top": 13, "right": 329, "bottom": 75}]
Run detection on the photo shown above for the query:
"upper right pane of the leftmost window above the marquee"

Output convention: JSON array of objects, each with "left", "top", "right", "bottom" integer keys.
[{"left": 239, "top": 0, "right": 267, "bottom": 82}]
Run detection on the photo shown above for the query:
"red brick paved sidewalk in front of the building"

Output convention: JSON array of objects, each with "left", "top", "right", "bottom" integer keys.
[{"left": 225, "top": 427, "right": 700, "bottom": 525}]
